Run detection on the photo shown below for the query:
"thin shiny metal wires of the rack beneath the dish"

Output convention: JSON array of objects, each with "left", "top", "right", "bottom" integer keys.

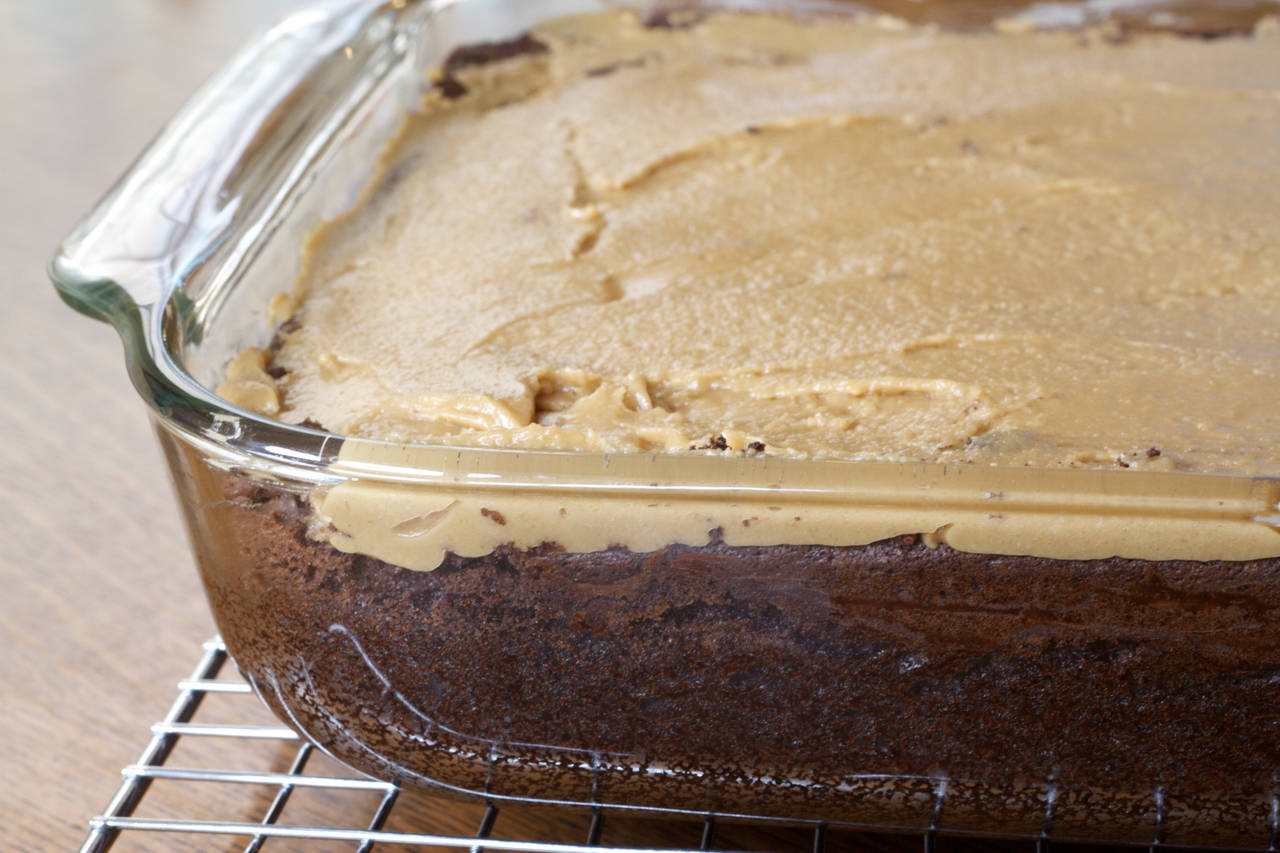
[{"left": 81, "top": 639, "right": 1239, "bottom": 853}]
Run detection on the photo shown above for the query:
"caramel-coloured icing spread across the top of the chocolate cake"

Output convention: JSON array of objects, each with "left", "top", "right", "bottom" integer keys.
[{"left": 220, "top": 13, "right": 1280, "bottom": 474}]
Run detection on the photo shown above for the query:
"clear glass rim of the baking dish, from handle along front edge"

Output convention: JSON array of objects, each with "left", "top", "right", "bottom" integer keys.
[{"left": 49, "top": 0, "right": 1280, "bottom": 529}]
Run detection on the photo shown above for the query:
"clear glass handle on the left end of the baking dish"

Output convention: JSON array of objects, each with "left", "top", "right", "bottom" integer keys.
[{"left": 49, "top": 0, "right": 416, "bottom": 325}]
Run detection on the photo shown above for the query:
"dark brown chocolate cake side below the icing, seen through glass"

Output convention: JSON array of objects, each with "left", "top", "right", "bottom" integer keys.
[{"left": 180, "top": 466, "right": 1280, "bottom": 844}]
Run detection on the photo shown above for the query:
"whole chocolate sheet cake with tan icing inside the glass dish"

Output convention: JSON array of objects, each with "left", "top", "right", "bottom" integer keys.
[{"left": 186, "top": 4, "right": 1280, "bottom": 847}]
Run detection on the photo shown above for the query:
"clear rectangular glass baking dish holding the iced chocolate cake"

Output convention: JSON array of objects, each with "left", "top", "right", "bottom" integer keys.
[{"left": 51, "top": 0, "right": 1280, "bottom": 848}]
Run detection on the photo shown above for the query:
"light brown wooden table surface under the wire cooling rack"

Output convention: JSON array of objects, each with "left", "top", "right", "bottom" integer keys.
[{"left": 0, "top": 0, "right": 1111, "bottom": 850}]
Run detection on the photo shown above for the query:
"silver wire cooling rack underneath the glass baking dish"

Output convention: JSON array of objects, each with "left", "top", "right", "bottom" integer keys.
[{"left": 81, "top": 639, "right": 1239, "bottom": 853}]
